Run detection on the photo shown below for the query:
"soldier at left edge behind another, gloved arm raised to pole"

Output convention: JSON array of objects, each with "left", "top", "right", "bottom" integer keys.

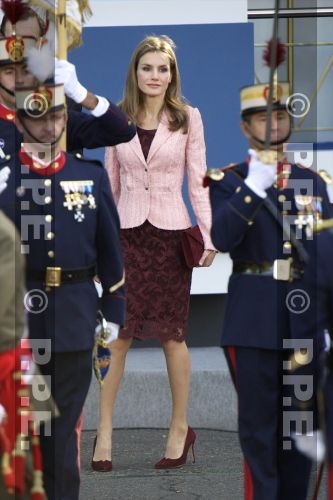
[{"left": 0, "top": 31, "right": 136, "bottom": 158}]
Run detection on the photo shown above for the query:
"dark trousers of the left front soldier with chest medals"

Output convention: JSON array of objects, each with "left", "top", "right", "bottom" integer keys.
[{"left": 40, "top": 350, "right": 92, "bottom": 500}]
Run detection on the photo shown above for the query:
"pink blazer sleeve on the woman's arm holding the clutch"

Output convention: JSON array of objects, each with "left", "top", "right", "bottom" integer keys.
[{"left": 185, "top": 108, "right": 215, "bottom": 250}]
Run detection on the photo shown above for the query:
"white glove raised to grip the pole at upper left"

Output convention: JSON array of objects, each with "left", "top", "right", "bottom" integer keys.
[{"left": 54, "top": 58, "right": 88, "bottom": 104}]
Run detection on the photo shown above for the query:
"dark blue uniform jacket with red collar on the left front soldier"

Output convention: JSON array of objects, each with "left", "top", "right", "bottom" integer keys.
[{"left": 0, "top": 153, "right": 125, "bottom": 352}]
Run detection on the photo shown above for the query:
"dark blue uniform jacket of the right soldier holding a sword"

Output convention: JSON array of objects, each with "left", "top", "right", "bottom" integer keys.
[{"left": 208, "top": 163, "right": 331, "bottom": 349}]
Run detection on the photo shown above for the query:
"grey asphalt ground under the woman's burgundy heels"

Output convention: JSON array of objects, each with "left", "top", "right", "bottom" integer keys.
[{"left": 80, "top": 428, "right": 327, "bottom": 500}]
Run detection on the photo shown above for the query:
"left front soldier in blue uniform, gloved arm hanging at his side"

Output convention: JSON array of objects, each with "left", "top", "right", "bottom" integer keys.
[{"left": 0, "top": 79, "right": 125, "bottom": 500}]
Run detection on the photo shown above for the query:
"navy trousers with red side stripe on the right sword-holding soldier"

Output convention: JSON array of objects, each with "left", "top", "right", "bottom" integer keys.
[{"left": 224, "top": 346, "right": 311, "bottom": 500}]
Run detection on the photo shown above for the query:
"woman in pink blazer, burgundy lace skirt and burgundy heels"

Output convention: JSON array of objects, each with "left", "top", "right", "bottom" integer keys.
[{"left": 92, "top": 36, "right": 215, "bottom": 471}]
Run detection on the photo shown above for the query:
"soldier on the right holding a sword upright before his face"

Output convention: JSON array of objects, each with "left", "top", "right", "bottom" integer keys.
[{"left": 205, "top": 73, "right": 330, "bottom": 500}]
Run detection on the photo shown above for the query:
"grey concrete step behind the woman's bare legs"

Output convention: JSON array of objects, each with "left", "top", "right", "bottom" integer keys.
[{"left": 83, "top": 347, "right": 237, "bottom": 431}]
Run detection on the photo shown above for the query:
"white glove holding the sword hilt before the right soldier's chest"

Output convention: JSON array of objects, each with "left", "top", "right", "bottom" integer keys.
[{"left": 244, "top": 149, "right": 277, "bottom": 198}]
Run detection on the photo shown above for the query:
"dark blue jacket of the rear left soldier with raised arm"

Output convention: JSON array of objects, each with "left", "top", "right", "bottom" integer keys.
[{"left": 0, "top": 103, "right": 136, "bottom": 158}]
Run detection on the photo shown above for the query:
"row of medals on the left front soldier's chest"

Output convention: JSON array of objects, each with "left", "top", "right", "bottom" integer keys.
[{"left": 60, "top": 180, "right": 96, "bottom": 222}]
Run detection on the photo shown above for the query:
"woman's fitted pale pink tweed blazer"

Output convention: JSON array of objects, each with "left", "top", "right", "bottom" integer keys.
[{"left": 105, "top": 106, "right": 214, "bottom": 249}]
